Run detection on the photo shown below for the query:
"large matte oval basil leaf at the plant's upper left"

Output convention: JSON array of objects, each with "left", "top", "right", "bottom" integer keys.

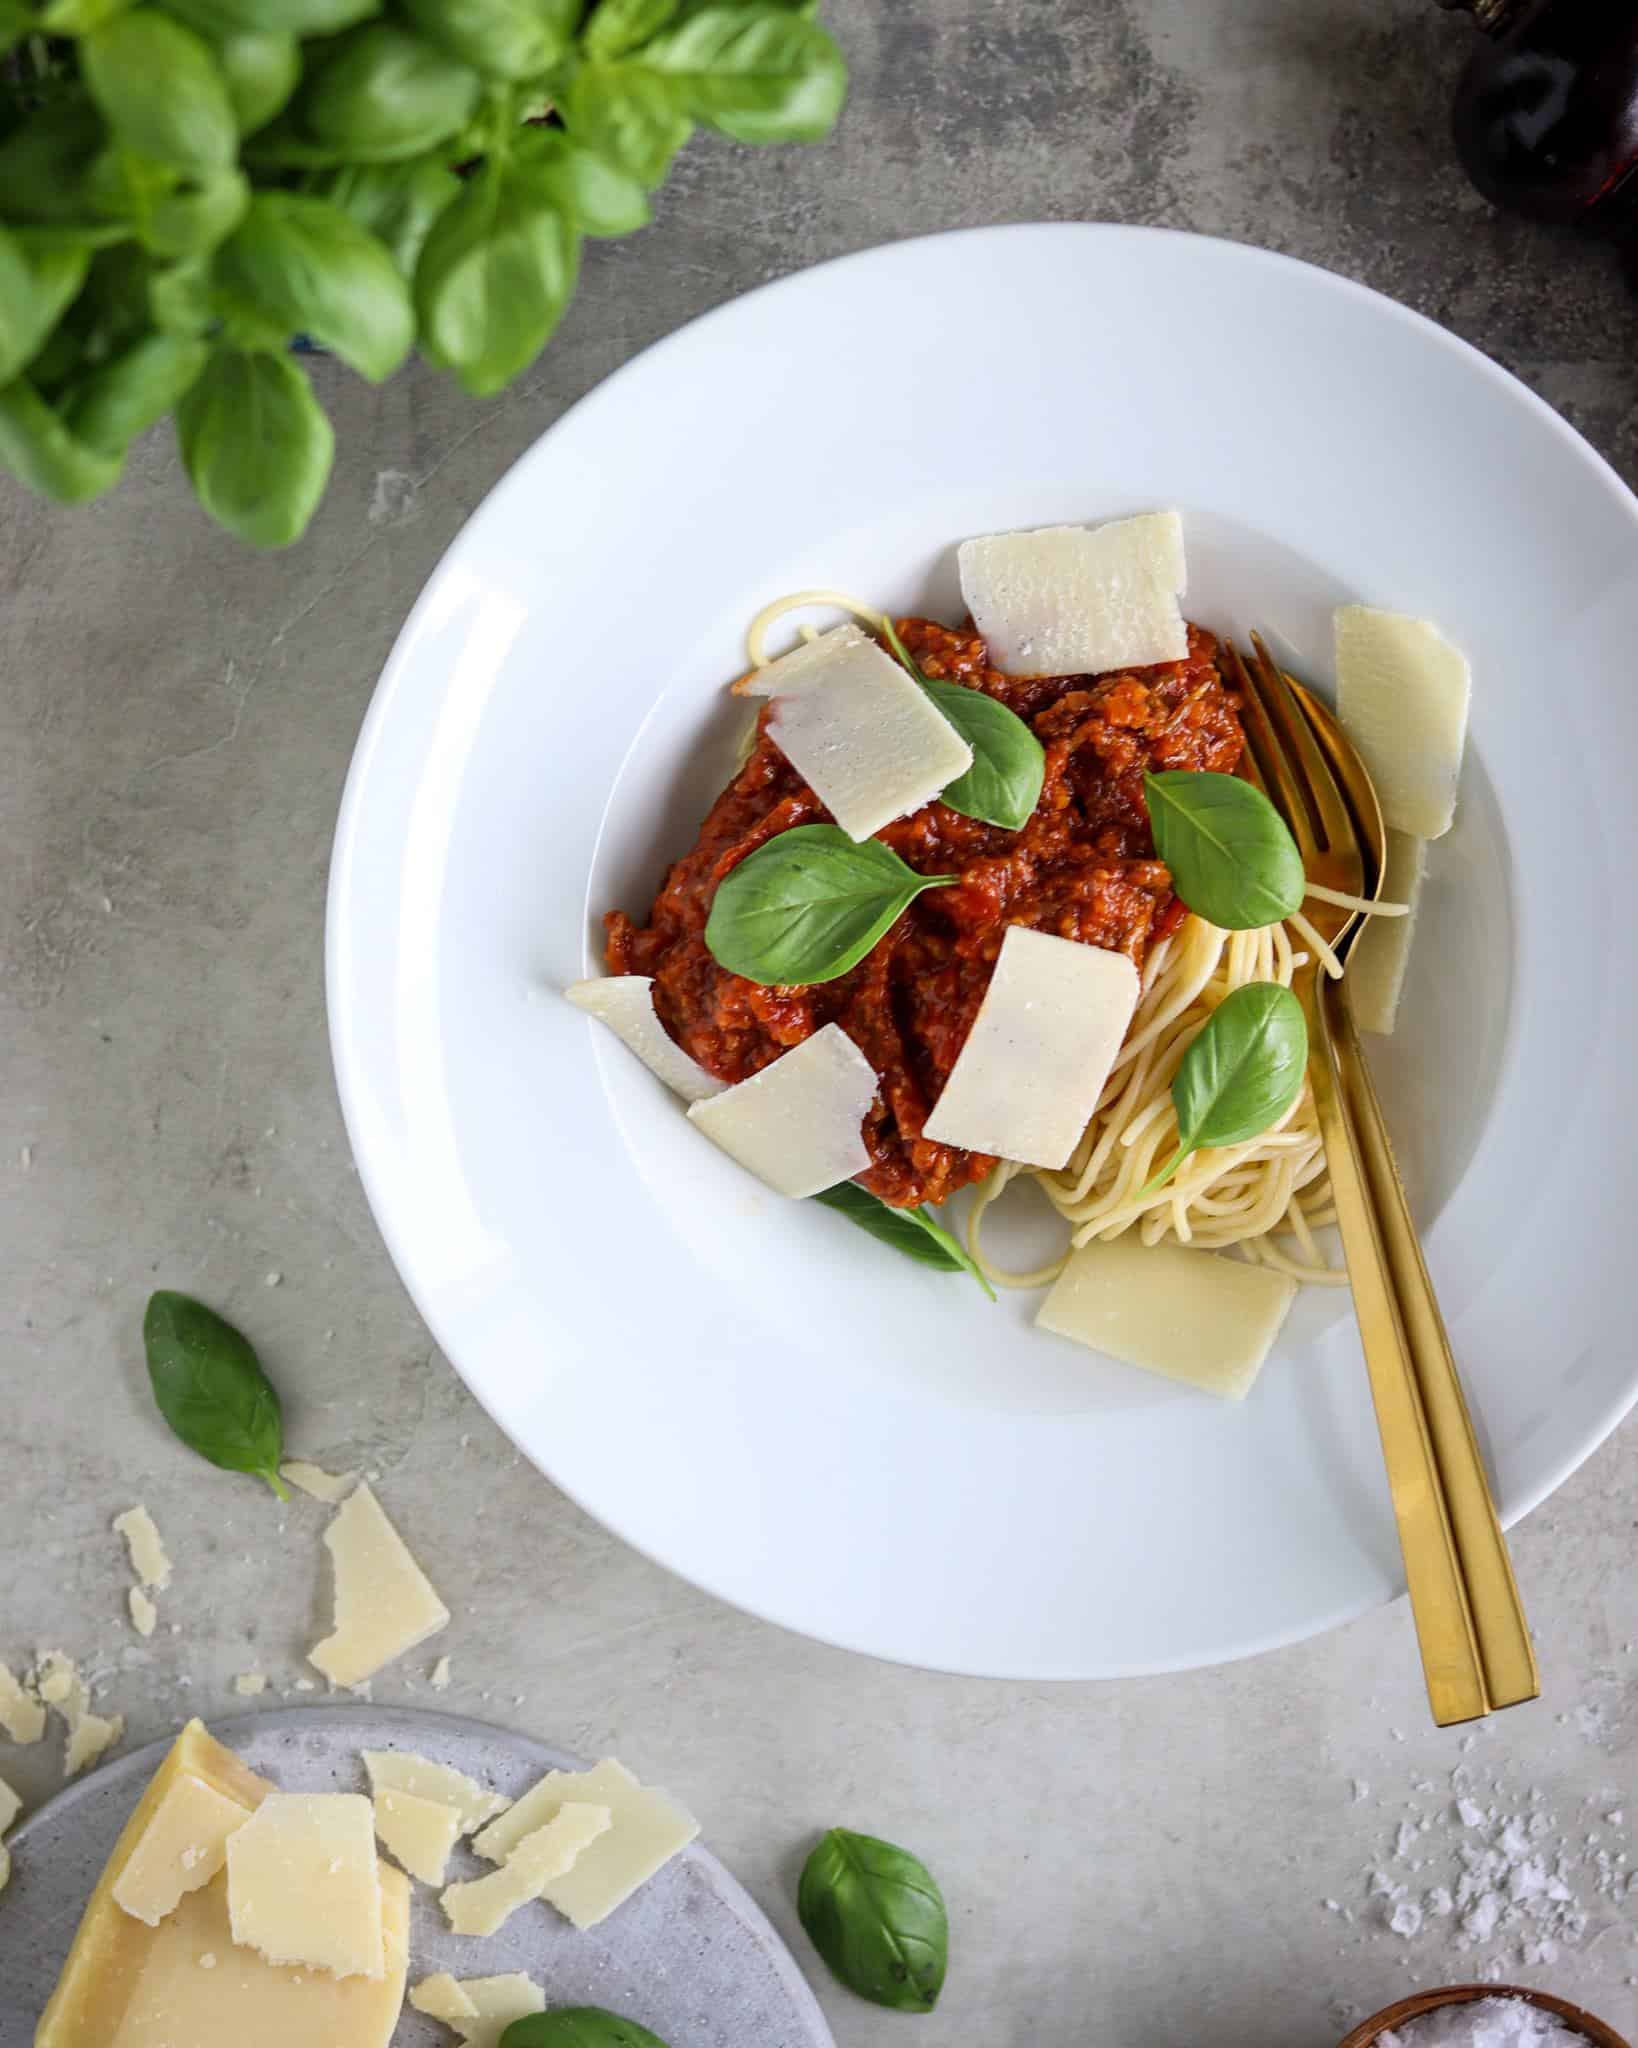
[{"left": 80, "top": 6, "right": 240, "bottom": 174}]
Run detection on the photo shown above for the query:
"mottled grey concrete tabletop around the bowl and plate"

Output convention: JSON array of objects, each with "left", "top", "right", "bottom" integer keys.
[{"left": 0, "top": 0, "right": 1638, "bottom": 2048}]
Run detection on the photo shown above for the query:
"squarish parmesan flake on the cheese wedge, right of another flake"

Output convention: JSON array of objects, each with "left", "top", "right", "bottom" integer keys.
[{"left": 227, "top": 1792, "right": 385, "bottom": 1976}]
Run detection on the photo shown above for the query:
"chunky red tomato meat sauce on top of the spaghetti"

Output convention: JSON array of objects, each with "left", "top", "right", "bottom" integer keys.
[{"left": 604, "top": 618, "right": 1243, "bottom": 1206}]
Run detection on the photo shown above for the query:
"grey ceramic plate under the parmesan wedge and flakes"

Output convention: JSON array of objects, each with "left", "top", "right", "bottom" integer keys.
[{"left": 0, "top": 1704, "right": 833, "bottom": 2048}]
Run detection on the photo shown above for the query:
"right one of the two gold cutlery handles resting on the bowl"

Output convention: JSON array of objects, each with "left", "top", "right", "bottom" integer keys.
[{"left": 1319, "top": 983, "right": 1542, "bottom": 1708}]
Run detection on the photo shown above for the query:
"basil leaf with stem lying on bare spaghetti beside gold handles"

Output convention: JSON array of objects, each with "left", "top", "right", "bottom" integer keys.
[{"left": 1143, "top": 981, "right": 1308, "bottom": 1194}]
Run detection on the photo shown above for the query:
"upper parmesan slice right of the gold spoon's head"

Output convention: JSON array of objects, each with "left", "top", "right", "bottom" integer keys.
[{"left": 1335, "top": 604, "right": 1472, "bottom": 840}]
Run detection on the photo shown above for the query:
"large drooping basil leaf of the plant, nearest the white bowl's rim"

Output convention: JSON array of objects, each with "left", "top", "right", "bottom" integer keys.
[{"left": 416, "top": 160, "right": 579, "bottom": 397}]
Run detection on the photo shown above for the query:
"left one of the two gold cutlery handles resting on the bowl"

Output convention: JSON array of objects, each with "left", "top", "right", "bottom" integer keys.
[{"left": 1302, "top": 973, "right": 1491, "bottom": 1726}]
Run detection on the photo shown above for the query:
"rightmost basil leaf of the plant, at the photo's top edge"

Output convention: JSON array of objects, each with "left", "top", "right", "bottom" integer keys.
[{"left": 643, "top": 6, "right": 848, "bottom": 141}]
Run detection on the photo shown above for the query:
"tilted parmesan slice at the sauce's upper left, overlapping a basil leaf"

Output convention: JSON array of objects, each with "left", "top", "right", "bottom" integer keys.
[{"left": 741, "top": 625, "right": 973, "bottom": 840}]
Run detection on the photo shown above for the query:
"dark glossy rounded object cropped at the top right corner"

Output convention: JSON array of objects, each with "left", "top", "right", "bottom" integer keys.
[{"left": 1441, "top": 0, "right": 1638, "bottom": 236}]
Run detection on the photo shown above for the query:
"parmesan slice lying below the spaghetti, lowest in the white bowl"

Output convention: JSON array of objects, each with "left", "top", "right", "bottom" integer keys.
[{"left": 1036, "top": 1235, "right": 1296, "bottom": 1401}]
